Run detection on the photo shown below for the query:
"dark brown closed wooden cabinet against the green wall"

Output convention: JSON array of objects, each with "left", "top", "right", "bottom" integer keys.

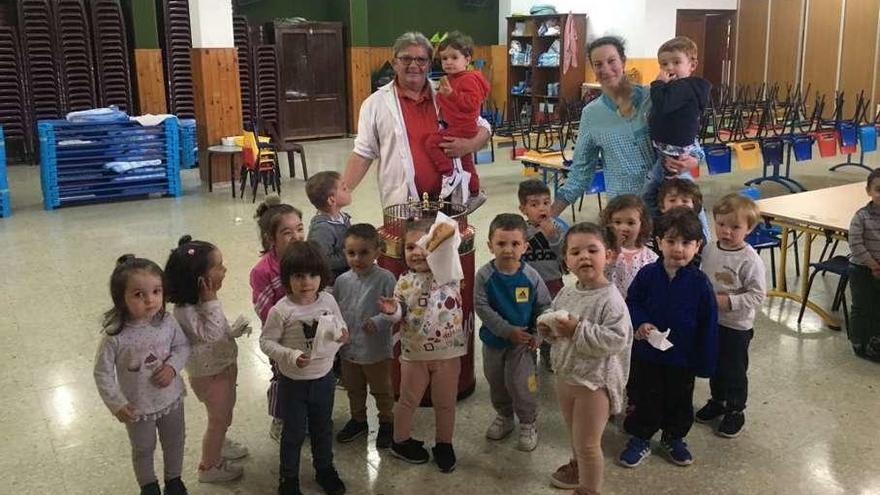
[{"left": 273, "top": 22, "right": 348, "bottom": 141}]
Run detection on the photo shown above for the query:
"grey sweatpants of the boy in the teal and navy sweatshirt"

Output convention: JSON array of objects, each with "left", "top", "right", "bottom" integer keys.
[{"left": 483, "top": 344, "right": 538, "bottom": 424}]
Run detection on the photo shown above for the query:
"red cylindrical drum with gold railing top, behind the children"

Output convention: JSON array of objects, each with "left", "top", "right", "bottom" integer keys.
[{"left": 379, "top": 201, "right": 477, "bottom": 407}]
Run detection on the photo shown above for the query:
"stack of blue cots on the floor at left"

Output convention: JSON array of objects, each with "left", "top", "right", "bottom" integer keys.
[{"left": 37, "top": 118, "right": 181, "bottom": 210}]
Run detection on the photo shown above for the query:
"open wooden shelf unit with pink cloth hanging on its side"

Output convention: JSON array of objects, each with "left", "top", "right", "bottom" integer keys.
[{"left": 507, "top": 14, "right": 587, "bottom": 120}]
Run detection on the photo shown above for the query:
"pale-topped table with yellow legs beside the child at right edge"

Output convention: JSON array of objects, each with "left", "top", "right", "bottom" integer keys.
[{"left": 757, "top": 182, "right": 868, "bottom": 328}]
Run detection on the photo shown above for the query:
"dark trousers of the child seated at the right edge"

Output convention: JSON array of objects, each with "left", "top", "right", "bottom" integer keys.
[{"left": 846, "top": 264, "right": 880, "bottom": 360}]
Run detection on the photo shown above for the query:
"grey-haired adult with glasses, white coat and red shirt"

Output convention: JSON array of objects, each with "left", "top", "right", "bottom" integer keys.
[{"left": 342, "top": 32, "right": 491, "bottom": 211}]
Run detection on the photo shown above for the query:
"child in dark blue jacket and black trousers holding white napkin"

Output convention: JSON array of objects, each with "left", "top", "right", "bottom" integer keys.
[{"left": 619, "top": 207, "right": 718, "bottom": 467}]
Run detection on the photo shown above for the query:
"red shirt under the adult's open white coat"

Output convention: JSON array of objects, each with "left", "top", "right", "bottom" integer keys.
[{"left": 397, "top": 83, "right": 441, "bottom": 199}]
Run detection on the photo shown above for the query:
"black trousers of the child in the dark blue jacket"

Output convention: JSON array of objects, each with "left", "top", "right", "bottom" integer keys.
[{"left": 623, "top": 358, "right": 694, "bottom": 441}]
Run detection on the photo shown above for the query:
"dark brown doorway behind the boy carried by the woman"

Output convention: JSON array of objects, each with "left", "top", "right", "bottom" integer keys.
[{"left": 675, "top": 9, "right": 736, "bottom": 86}]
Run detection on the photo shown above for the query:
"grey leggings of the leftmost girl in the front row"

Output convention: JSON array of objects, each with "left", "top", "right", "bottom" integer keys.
[{"left": 125, "top": 404, "right": 186, "bottom": 486}]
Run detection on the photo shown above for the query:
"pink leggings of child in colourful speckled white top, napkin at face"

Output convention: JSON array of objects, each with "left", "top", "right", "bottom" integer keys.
[{"left": 394, "top": 357, "right": 461, "bottom": 443}]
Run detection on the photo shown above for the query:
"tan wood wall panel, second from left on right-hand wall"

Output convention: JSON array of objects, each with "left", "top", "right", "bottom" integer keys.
[{"left": 767, "top": 0, "right": 804, "bottom": 87}]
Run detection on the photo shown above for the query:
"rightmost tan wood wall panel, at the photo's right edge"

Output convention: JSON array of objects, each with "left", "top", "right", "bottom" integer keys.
[{"left": 839, "top": 0, "right": 880, "bottom": 119}]
